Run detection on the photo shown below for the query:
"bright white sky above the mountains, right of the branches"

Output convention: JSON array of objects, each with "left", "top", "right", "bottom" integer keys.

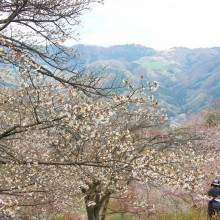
[{"left": 69, "top": 0, "right": 220, "bottom": 49}]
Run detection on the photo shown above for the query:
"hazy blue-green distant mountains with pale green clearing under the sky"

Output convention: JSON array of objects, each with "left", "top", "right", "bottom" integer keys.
[{"left": 74, "top": 44, "right": 220, "bottom": 119}]
